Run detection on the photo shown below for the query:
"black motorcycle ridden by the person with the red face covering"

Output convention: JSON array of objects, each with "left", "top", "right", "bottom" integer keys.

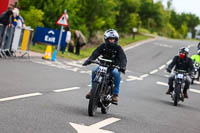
[{"left": 171, "top": 70, "right": 188, "bottom": 106}]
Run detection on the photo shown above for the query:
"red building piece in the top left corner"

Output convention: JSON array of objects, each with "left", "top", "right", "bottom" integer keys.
[{"left": 0, "top": 0, "right": 18, "bottom": 15}]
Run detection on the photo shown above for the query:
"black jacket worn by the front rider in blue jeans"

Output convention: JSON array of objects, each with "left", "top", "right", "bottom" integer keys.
[{"left": 89, "top": 43, "right": 127, "bottom": 70}]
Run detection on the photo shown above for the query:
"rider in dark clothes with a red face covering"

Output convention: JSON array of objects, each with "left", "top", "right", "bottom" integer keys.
[{"left": 166, "top": 48, "right": 193, "bottom": 98}]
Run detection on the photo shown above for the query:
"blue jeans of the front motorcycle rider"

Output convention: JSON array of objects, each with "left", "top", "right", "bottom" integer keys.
[{"left": 92, "top": 67, "right": 120, "bottom": 95}]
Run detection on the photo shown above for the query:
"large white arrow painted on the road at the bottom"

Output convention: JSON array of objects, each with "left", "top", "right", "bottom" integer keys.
[{"left": 69, "top": 118, "right": 120, "bottom": 133}]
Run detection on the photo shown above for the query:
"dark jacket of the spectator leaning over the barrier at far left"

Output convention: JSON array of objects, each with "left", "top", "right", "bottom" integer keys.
[{"left": 0, "top": 10, "right": 13, "bottom": 25}]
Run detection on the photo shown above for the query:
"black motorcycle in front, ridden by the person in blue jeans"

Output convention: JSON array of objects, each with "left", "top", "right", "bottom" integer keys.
[{"left": 88, "top": 58, "right": 119, "bottom": 116}]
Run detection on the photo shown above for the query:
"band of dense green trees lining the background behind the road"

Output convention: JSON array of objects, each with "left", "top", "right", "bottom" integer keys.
[{"left": 18, "top": 0, "right": 200, "bottom": 41}]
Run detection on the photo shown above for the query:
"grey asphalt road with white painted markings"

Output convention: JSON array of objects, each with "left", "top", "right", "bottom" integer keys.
[{"left": 0, "top": 38, "right": 200, "bottom": 133}]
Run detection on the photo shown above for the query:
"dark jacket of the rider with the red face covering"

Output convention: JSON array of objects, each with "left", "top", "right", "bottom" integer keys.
[{"left": 168, "top": 55, "right": 194, "bottom": 73}]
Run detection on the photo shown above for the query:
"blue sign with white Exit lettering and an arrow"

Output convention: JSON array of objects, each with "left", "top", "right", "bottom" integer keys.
[{"left": 33, "top": 27, "right": 67, "bottom": 48}]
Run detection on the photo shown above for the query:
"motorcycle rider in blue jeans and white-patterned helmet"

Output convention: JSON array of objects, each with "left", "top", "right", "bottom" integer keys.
[{"left": 83, "top": 29, "right": 127, "bottom": 103}]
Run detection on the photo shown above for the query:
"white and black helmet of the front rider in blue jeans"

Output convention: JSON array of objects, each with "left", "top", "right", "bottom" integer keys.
[{"left": 104, "top": 29, "right": 119, "bottom": 45}]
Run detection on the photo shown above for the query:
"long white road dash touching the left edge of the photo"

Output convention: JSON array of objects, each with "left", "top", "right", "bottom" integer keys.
[{"left": 0, "top": 93, "right": 42, "bottom": 102}]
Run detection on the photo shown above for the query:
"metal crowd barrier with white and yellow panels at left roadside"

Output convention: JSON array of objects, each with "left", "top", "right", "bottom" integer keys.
[{"left": 0, "top": 25, "right": 33, "bottom": 58}]
